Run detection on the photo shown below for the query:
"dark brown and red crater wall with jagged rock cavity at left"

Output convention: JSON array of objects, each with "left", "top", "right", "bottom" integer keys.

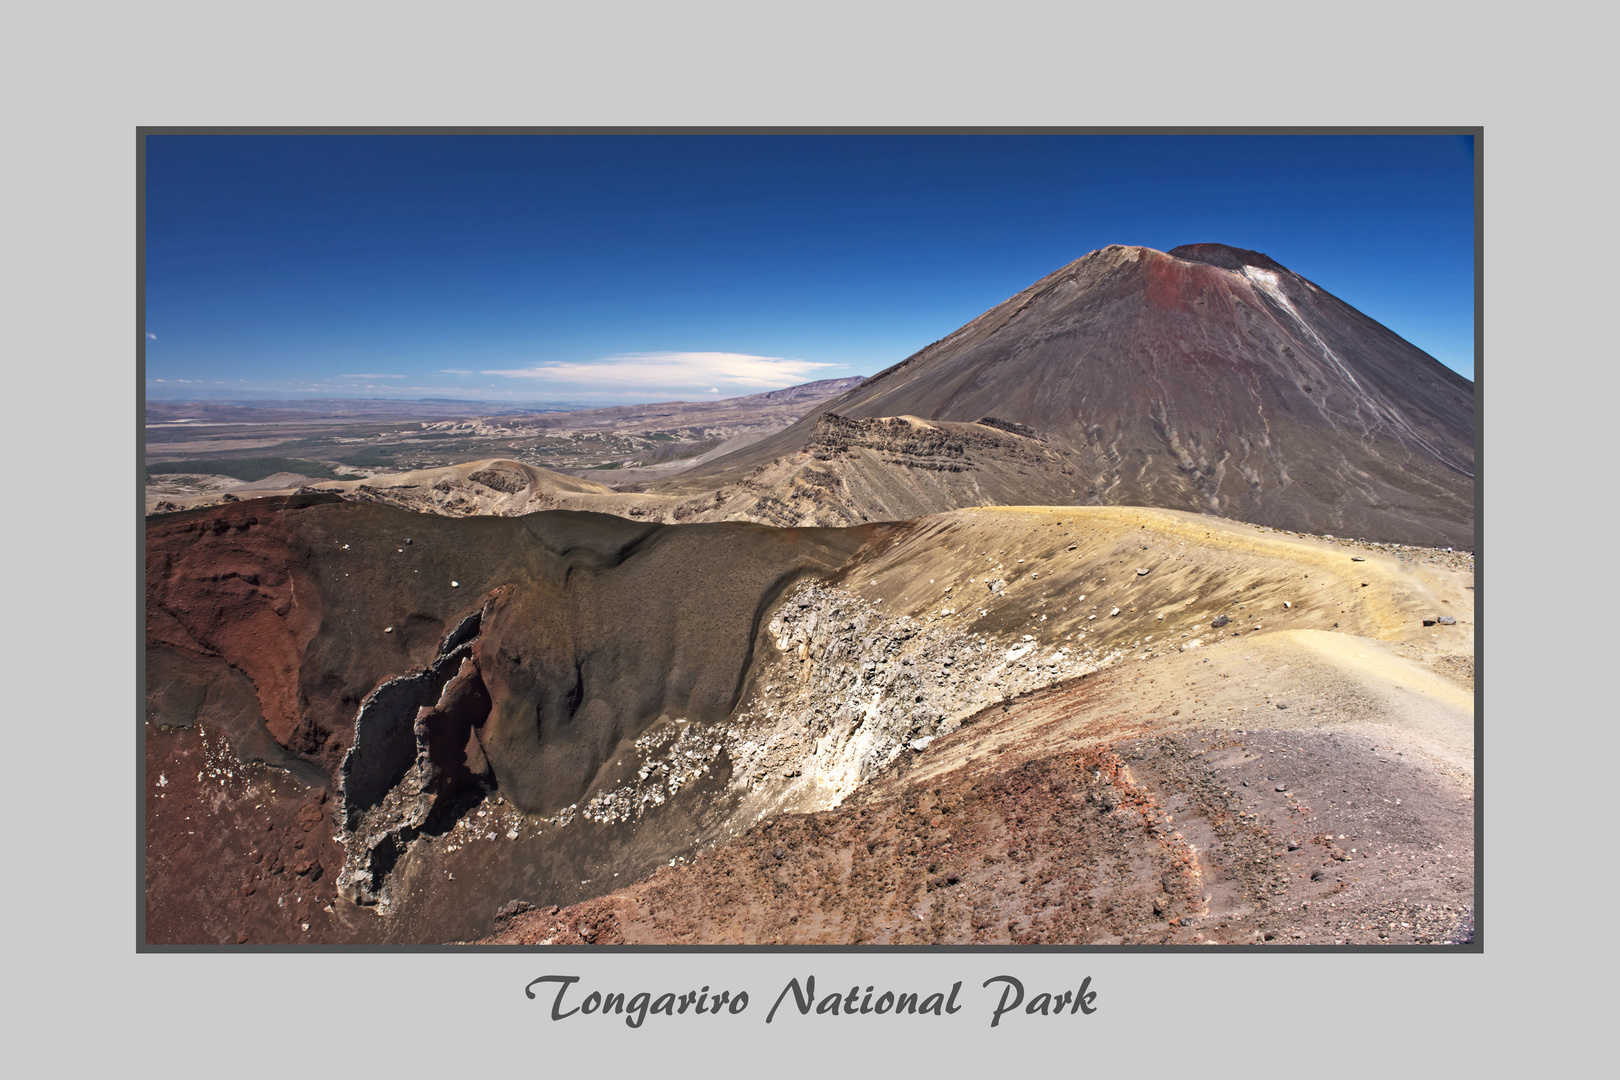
[{"left": 147, "top": 497, "right": 876, "bottom": 827}]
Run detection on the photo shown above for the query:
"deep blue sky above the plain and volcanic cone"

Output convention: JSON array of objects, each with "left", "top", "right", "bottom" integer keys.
[{"left": 146, "top": 134, "right": 1474, "bottom": 402}]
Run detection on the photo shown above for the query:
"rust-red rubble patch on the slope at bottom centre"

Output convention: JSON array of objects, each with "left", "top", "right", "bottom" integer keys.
[{"left": 489, "top": 748, "right": 1200, "bottom": 946}]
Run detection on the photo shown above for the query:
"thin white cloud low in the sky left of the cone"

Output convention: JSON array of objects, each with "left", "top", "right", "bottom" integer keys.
[{"left": 480, "top": 353, "right": 834, "bottom": 393}]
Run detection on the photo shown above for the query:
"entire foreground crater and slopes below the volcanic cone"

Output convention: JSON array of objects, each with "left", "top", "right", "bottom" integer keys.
[{"left": 144, "top": 495, "right": 1473, "bottom": 942}]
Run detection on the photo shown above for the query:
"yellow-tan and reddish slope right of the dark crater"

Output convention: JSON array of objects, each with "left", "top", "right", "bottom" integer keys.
[{"left": 486, "top": 508, "right": 1474, "bottom": 946}]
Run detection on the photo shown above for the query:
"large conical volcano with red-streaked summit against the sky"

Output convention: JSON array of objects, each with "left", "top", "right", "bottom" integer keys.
[{"left": 650, "top": 244, "right": 1474, "bottom": 547}]
